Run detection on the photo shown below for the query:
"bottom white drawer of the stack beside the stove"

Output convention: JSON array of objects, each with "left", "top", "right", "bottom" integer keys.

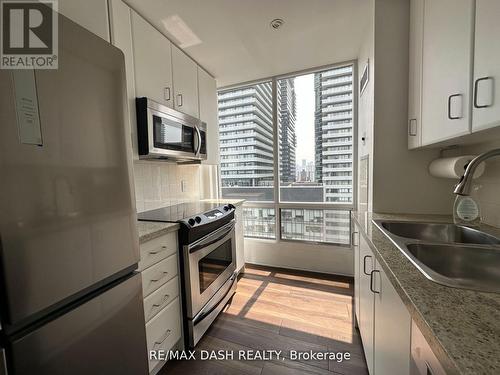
[{"left": 146, "top": 297, "right": 181, "bottom": 372}]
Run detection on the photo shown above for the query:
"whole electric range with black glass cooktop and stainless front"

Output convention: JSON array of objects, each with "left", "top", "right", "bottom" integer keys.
[{"left": 138, "top": 202, "right": 237, "bottom": 348}]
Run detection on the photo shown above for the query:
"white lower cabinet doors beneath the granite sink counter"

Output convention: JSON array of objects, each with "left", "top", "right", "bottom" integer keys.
[{"left": 353, "top": 226, "right": 411, "bottom": 375}]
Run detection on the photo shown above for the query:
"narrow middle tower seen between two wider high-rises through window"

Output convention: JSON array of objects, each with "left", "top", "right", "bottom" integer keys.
[{"left": 277, "top": 78, "right": 297, "bottom": 184}]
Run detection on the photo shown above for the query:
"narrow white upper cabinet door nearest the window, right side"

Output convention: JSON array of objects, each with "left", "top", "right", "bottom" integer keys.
[{"left": 408, "top": 0, "right": 424, "bottom": 149}]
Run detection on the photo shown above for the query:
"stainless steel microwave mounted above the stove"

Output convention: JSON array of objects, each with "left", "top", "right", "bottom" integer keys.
[{"left": 135, "top": 98, "right": 207, "bottom": 161}]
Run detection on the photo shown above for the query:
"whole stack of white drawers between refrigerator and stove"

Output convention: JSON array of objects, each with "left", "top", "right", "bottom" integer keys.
[{"left": 139, "top": 232, "right": 182, "bottom": 373}]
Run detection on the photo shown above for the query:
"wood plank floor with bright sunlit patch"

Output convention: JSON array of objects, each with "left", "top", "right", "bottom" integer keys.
[{"left": 160, "top": 265, "right": 368, "bottom": 375}]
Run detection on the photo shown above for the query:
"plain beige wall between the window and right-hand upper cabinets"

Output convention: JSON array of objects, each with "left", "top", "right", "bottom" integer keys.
[{"left": 360, "top": 0, "right": 454, "bottom": 214}]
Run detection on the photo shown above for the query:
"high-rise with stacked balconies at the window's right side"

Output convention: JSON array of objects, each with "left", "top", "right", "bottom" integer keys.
[{"left": 314, "top": 66, "right": 353, "bottom": 203}]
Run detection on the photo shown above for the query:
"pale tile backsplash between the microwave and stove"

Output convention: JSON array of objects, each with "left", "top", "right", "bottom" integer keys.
[{"left": 134, "top": 161, "right": 203, "bottom": 212}]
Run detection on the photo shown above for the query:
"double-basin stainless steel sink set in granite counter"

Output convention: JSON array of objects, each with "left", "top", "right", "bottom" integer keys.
[{"left": 373, "top": 220, "right": 500, "bottom": 293}]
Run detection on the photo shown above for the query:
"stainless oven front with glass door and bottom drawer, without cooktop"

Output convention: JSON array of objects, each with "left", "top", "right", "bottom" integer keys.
[{"left": 183, "top": 219, "right": 236, "bottom": 347}]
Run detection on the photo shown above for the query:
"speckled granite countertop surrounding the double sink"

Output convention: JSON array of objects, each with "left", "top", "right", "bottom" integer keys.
[{"left": 352, "top": 212, "right": 500, "bottom": 374}]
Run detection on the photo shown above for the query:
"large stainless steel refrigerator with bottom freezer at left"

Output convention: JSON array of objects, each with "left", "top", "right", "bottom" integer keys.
[{"left": 0, "top": 7, "right": 148, "bottom": 375}]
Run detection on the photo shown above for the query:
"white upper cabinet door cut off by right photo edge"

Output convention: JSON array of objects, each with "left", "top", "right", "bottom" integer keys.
[{"left": 472, "top": 0, "right": 500, "bottom": 131}]
